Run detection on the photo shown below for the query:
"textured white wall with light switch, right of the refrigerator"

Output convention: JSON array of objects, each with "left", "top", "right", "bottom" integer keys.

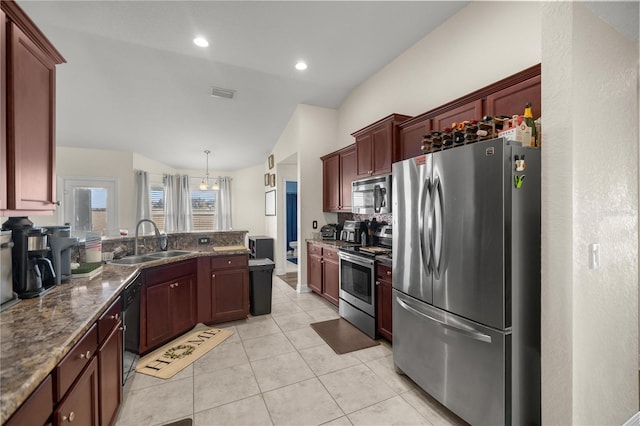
[{"left": 542, "top": 3, "right": 638, "bottom": 424}]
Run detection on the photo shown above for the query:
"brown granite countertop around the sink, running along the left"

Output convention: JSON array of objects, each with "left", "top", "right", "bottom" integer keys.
[{"left": 0, "top": 246, "right": 249, "bottom": 424}]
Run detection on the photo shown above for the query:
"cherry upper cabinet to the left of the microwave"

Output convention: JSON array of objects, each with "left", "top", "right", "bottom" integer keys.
[{"left": 321, "top": 144, "right": 357, "bottom": 212}]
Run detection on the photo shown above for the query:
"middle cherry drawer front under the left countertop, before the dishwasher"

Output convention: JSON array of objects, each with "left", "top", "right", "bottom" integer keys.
[{"left": 55, "top": 324, "right": 98, "bottom": 402}]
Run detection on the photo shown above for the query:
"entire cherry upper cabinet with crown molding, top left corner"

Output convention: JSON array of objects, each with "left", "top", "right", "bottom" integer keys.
[{"left": 0, "top": 0, "right": 65, "bottom": 216}]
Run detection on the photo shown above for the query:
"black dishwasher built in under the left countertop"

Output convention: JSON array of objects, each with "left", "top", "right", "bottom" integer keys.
[{"left": 120, "top": 274, "right": 142, "bottom": 386}]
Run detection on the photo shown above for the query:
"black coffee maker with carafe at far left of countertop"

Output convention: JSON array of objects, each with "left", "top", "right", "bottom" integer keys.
[{"left": 2, "top": 217, "right": 56, "bottom": 299}]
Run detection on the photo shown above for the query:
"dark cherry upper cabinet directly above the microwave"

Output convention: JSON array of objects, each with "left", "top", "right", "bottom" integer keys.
[{"left": 351, "top": 114, "right": 411, "bottom": 177}]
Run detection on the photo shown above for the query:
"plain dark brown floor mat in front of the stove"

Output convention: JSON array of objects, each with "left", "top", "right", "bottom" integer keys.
[{"left": 311, "top": 318, "right": 380, "bottom": 355}]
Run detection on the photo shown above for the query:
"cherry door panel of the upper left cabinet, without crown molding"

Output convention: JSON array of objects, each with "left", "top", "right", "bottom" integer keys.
[{"left": 6, "top": 23, "right": 56, "bottom": 211}]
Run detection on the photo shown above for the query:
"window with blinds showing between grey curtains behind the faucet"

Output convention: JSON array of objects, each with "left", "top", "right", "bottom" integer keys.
[{"left": 150, "top": 178, "right": 218, "bottom": 231}]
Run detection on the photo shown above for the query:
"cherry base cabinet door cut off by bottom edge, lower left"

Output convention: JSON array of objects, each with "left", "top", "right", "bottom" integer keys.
[{"left": 54, "top": 357, "right": 99, "bottom": 426}]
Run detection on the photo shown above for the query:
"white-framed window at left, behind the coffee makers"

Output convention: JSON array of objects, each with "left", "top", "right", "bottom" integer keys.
[{"left": 58, "top": 177, "right": 119, "bottom": 238}]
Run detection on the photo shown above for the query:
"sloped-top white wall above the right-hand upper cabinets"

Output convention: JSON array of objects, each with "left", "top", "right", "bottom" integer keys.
[{"left": 336, "top": 1, "right": 541, "bottom": 152}]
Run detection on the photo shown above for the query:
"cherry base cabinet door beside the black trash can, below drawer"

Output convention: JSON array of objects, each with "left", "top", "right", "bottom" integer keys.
[{"left": 211, "top": 269, "right": 249, "bottom": 322}]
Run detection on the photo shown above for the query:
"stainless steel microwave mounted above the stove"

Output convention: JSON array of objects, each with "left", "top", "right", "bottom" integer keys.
[{"left": 351, "top": 175, "right": 391, "bottom": 214}]
